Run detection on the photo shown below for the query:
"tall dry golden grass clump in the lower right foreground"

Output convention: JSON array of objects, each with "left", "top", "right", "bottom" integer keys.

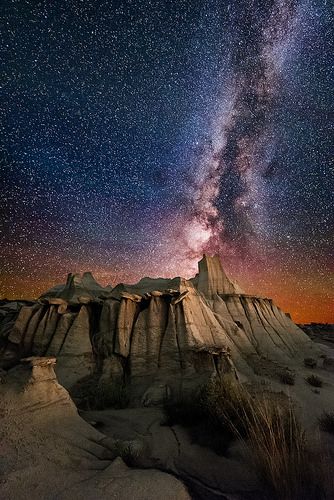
[{"left": 167, "top": 379, "right": 334, "bottom": 500}]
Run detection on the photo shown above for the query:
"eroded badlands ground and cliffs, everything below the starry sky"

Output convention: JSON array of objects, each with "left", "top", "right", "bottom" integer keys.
[{"left": 0, "top": 256, "right": 334, "bottom": 500}]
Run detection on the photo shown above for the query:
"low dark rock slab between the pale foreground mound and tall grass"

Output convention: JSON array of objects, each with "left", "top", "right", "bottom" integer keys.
[{"left": 83, "top": 408, "right": 260, "bottom": 500}]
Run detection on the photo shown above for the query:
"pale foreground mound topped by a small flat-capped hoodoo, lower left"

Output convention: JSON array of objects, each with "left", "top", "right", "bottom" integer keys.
[{"left": 0, "top": 357, "right": 190, "bottom": 500}]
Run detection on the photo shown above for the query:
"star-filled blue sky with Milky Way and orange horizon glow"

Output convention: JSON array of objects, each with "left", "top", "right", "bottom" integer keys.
[{"left": 0, "top": 0, "right": 334, "bottom": 322}]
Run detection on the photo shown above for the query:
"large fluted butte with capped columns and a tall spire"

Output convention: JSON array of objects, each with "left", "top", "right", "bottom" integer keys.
[{"left": 0, "top": 256, "right": 316, "bottom": 405}]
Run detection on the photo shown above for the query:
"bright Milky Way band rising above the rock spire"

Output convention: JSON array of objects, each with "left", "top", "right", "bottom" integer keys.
[{"left": 181, "top": 1, "right": 318, "bottom": 257}]
